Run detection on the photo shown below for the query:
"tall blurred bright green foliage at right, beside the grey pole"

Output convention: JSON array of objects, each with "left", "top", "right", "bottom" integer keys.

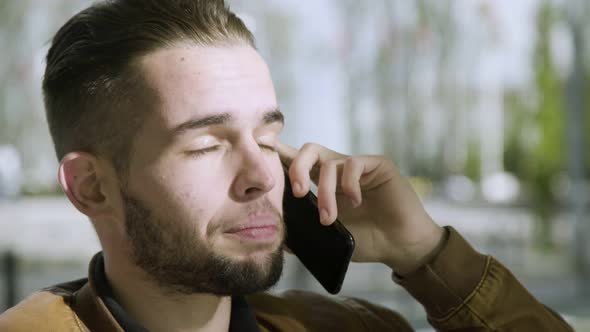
[{"left": 504, "top": 2, "right": 566, "bottom": 247}]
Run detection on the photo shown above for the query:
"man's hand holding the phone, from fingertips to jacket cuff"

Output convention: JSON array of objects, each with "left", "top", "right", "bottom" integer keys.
[{"left": 277, "top": 143, "right": 443, "bottom": 275}]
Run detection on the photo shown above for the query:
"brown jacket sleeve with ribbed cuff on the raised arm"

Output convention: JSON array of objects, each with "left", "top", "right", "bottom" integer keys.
[{"left": 393, "top": 226, "right": 573, "bottom": 332}]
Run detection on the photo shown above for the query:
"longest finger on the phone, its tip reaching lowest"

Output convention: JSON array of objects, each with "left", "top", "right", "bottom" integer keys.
[{"left": 318, "top": 160, "right": 342, "bottom": 225}]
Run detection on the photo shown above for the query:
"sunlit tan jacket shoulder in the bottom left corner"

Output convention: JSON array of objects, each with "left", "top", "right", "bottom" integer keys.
[{"left": 0, "top": 280, "right": 86, "bottom": 332}]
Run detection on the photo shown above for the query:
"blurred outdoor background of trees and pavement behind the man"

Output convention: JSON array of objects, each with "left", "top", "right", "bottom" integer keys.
[{"left": 0, "top": 0, "right": 590, "bottom": 331}]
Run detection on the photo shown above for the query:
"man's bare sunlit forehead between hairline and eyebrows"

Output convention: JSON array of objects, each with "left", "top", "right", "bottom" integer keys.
[{"left": 139, "top": 45, "right": 276, "bottom": 127}]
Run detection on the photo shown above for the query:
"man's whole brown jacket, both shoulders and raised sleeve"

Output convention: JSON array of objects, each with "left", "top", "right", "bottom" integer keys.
[{"left": 0, "top": 227, "right": 572, "bottom": 332}]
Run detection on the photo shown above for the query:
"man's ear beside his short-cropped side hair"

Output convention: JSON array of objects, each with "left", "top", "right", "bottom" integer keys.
[{"left": 58, "top": 152, "right": 111, "bottom": 218}]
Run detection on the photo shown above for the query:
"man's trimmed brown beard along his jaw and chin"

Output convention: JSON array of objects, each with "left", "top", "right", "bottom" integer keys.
[{"left": 121, "top": 191, "right": 284, "bottom": 296}]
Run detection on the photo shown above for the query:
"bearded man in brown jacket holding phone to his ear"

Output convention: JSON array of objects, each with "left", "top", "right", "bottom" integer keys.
[{"left": 0, "top": 0, "right": 569, "bottom": 331}]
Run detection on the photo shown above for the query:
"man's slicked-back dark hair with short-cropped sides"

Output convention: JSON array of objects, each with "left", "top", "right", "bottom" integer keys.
[{"left": 43, "top": 0, "right": 255, "bottom": 172}]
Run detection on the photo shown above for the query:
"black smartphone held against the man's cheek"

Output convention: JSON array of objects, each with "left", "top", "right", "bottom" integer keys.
[{"left": 283, "top": 170, "right": 354, "bottom": 294}]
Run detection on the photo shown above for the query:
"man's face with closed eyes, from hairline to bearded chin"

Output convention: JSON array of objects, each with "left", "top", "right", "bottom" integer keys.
[{"left": 121, "top": 45, "right": 284, "bottom": 295}]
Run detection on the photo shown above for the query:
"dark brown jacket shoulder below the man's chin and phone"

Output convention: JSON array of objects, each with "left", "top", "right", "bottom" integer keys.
[{"left": 247, "top": 290, "right": 412, "bottom": 331}]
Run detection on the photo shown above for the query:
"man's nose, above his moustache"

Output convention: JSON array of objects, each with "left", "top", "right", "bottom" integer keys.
[{"left": 231, "top": 145, "right": 276, "bottom": 202}]
